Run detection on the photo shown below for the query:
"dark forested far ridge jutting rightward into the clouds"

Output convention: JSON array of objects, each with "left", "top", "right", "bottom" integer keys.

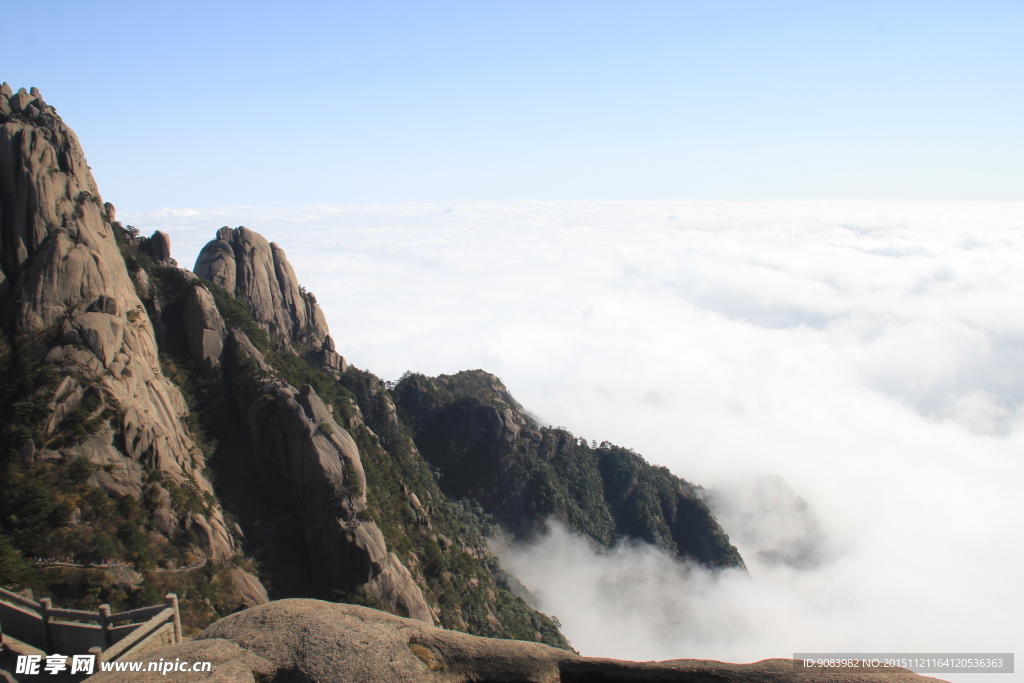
[{"left": 394, "top": 370, "right": 742, "bottom": 568}]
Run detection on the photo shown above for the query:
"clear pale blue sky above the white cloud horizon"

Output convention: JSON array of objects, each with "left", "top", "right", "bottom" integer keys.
[{"left": 0, "top": 1, "right": 1024, "bottom": 205}]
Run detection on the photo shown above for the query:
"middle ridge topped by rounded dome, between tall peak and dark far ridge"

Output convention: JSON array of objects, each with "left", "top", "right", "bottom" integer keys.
[{"left": 71, "top": 216, "right": 567, "bottom": 646}]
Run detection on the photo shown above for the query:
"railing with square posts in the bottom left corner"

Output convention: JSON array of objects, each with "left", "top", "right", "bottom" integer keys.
[{"left": 0, "top": 589, "right": 181, "bottom": 661}]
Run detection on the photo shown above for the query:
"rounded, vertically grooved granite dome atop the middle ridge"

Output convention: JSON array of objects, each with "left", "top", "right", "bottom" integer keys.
[{"left": 195, "top": 226, "right": 345, "bottom": 372}]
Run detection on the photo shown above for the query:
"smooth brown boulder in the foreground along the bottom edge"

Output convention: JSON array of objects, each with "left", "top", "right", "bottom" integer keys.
[{"left": 88, "top": 599, "right": 937, "bottom": 683}]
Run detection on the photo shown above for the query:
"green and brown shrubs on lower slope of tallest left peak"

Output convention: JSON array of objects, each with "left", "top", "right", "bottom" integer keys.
[{"left": 0, "top": 224, "right": 262, "bottom": 632}]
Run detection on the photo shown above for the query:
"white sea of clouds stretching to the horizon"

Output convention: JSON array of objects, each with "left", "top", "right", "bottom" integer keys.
[{"left": 121, "top": 202, "right": 1024, "bottom": 681}]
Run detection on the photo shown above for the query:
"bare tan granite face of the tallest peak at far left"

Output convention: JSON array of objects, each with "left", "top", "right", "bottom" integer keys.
[{"left": 0, "top": 88, "right": 237, "bottom": 560}]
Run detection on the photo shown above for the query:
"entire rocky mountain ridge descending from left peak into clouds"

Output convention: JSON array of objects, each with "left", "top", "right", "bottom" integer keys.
[{"left": 0, "top": 86, "right": 742, "bottom": 648}]
